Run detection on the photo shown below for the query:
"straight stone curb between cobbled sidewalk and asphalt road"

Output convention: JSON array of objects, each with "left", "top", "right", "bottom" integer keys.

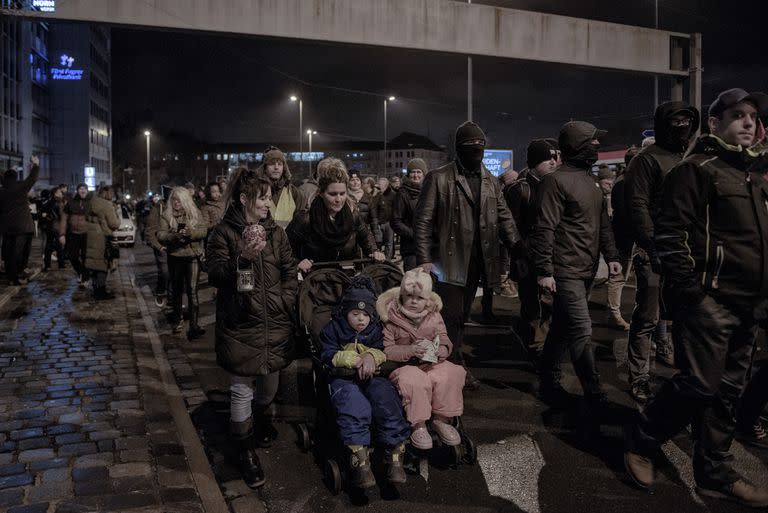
[{"left": 129, "top": 272, "right": 229, "bottom": 513}]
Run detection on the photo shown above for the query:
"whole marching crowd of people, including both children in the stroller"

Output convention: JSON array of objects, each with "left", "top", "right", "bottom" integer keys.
[{"left": 0, "top": 89, "right": 768, "bottom": 507}]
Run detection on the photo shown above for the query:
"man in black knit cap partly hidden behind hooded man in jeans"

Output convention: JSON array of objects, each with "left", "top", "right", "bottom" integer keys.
[{"left": 504, "top": 139, "right": 558, "bottom": 346}]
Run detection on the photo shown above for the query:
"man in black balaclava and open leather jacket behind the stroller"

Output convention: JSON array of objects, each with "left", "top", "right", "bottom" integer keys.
[{"left": 413, "top": 121, "right": 520, "bottom": 388}]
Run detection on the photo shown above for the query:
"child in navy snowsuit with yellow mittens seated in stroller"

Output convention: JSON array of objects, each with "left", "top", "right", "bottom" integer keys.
[{"left": 319, "top": 276, "right": 411, "bottom": 488}]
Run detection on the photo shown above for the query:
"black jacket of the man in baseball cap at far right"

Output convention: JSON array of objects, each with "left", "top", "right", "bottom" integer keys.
[{"left": 654, "top": 135, "right": 768, "bottom": 308}]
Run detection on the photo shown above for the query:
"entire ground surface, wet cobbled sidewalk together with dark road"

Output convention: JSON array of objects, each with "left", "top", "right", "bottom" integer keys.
[{"left": 0, "top": 240, "right": 768, "bottom": 513}]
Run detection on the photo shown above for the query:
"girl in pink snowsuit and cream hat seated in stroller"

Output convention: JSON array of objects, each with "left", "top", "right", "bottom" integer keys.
[{"left": 376, "top": 268, "right": 466, "bottom": 450}]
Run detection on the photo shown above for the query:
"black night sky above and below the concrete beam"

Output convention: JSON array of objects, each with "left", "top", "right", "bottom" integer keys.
[{"left": 112, "top": 0, "right": 768, "bottom": 168}]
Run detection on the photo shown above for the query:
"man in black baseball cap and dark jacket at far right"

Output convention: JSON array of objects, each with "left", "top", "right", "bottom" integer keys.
[{"left": 624, "top": 89, "right": 768, "bottom": 507}]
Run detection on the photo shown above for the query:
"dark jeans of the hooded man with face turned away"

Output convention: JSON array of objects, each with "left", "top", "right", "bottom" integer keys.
[{"left": 541, "top": 278, "right": 600, "bottom": 395}]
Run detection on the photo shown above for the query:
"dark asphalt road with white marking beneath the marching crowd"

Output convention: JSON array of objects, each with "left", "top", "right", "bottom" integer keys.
[{"left": 127, "top": 246, "right": 768, "bottom": 513}]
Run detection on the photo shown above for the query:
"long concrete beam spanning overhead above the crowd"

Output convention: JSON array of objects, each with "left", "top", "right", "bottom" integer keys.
[{"left": 0, "top": 0, "right": 701, "bottom": 108}]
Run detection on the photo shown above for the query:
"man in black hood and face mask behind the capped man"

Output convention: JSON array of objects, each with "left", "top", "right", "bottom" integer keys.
[{"left": 624, "top": 102, "right": 699, "bottom": 403}]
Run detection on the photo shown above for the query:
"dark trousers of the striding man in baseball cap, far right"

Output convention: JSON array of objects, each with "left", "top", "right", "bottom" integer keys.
[{"left": 627, "top": 296, "right": 757, "bottom": 488}]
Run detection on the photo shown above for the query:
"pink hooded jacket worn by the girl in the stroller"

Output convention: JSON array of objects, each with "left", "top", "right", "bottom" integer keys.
[{"left": 376, "top": 287, "right": 453, "bottom": 362}]
